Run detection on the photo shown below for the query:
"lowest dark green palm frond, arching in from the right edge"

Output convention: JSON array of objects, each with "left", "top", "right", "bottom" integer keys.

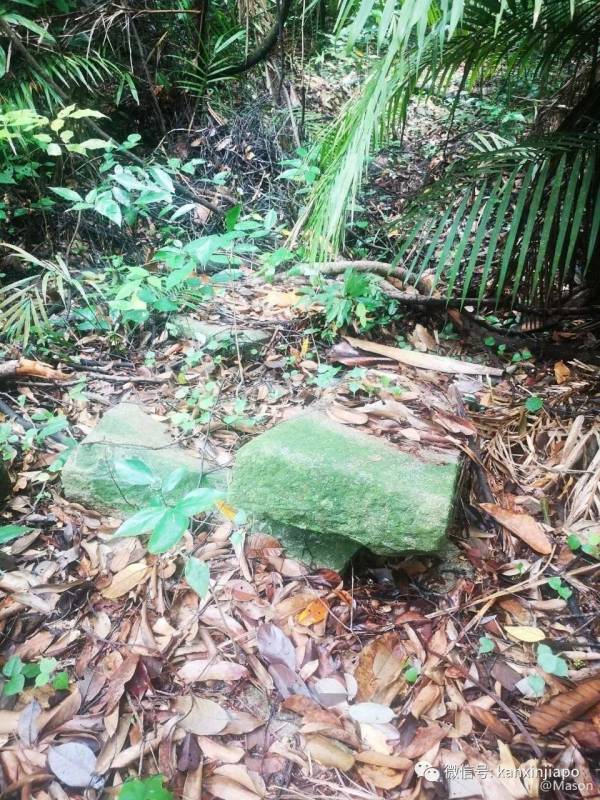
[{"left": 397, "top": 134, "right": 600, "bottom": 302}]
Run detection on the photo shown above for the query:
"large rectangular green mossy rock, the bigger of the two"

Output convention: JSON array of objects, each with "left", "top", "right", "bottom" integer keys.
[{"left": 231, "top": 411, "right": 459, "bottom": 566}]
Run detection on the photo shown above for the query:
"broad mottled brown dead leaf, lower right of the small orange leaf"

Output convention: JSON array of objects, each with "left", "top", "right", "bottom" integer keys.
[{"left": 354, "top": 633, "right": 407, "bottom": 705}]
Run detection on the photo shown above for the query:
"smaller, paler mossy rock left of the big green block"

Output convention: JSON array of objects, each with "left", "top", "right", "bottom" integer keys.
[{"left": 62, "top": 403, "right": 226, "bottom": 516}]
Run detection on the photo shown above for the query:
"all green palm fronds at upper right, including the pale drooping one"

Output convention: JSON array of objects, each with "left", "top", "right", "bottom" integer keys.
[{"left": 307, "top": 0, "right": 600, "bottom": 299}]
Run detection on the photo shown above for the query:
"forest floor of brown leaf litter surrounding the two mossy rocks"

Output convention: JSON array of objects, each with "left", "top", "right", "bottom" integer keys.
[{"left": 0, "top": 78, "right": 600, "bottom": 800}]
